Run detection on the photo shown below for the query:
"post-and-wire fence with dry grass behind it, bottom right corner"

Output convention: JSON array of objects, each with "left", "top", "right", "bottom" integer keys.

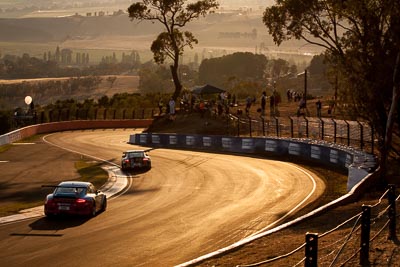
[{"left": 236, "top": 185, "right": 400, "bottom": 267}]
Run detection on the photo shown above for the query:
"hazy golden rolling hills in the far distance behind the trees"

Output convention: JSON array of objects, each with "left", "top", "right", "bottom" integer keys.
[{"left": 0, "top": 0, "right": 320, "bottom": 63}]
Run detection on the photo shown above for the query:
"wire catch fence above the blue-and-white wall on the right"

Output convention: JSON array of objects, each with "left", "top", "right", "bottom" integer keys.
[{"left": 226, "top": 114, "right": 376, "bottom": 154}]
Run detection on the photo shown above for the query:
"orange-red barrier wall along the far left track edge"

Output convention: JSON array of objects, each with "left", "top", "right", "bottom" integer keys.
[{"left": 0, "top": 119, "right": 153, "bottom": 146}]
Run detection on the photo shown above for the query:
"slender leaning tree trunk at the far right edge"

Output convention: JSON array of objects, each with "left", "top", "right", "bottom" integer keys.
[{"left": 381, "top": 53, "right": 400, "bottom": 182}]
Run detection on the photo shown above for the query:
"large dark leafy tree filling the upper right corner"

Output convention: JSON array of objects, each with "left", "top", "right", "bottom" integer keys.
[{"left": 263, "top": 0, "right": 400, "bottom": 181}]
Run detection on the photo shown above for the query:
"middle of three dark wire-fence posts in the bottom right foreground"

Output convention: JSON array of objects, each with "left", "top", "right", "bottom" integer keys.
[{"left": 360, "top": 205, "right": 371, "bottom": 266}]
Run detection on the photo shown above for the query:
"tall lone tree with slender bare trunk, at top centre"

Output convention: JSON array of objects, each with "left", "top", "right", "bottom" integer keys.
[{"left": 128, "top": 0, "right": 219, "bottom": 99}]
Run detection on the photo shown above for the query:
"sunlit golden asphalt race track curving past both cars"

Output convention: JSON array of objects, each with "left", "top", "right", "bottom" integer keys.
[{"left": 0, "top": 130, "right": 324, "bottom": 267}]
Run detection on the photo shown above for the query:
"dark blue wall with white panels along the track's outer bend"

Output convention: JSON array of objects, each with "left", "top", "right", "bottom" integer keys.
[{"left": 129, "top": 133, "right": 378, "bottom": 191}]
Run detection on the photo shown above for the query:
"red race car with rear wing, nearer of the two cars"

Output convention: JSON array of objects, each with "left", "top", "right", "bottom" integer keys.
[{"left": 42, "top": 181, "right": 107, "bottom": 217}]
